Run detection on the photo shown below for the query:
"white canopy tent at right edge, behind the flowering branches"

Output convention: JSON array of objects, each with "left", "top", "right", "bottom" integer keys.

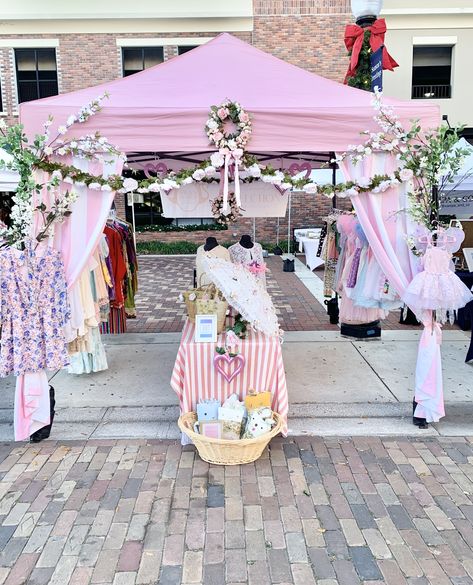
[{"left": 440, "top": 138, "right": 473, "bottom": 219}]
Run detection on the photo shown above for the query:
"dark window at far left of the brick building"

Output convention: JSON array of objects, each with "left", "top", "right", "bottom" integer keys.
[{"left": 15, "top": 49, "right": 58, "bottom": 103}]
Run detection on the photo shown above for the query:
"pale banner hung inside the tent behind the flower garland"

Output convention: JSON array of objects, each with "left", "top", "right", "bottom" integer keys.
[{"left": 161, "top": 181, "right": 288, "bottom": 219}]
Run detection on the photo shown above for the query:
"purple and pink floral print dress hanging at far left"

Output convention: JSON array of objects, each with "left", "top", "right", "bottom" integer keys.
[{"left": 0, "top": 243, "right": 70, "bottom": 377}]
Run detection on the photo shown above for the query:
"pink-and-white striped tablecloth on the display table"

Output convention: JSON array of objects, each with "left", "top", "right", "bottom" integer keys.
[{"left": 171, "top": 320, "right": 288, "bottom": 436}]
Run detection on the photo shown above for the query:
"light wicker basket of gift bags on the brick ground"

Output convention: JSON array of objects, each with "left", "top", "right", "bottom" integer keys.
[{"left": 177, "top": 412, "right": 283, "bottom": 465}]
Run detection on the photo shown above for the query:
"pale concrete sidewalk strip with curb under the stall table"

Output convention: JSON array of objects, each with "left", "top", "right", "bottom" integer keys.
[{"left": 0, "top": 331, "right": 473, "bottom": 440}]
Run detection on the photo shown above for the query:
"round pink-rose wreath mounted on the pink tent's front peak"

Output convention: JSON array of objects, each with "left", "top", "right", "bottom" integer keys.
[{"left": 205, "top": 100, "right": 251, "bottom": 150}]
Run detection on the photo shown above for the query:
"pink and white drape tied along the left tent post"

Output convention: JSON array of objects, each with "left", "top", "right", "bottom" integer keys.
[{"left": 14, "top": 158, "right": 122, "bottom": 441}]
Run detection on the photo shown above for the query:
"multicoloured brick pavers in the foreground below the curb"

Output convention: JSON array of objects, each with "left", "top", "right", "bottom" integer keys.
[{"left": 0, "top": 437, "right": 473, "bottom": 585}]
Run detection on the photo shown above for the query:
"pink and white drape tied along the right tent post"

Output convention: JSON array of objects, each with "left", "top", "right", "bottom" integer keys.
[{"left": 341, "top": 153, "right": 445, "bottom": 422}]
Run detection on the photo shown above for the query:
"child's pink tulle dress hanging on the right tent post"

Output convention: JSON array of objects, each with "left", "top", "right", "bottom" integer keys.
[{"left": 403, "top": 244, "right": 473, "bottom": 312}]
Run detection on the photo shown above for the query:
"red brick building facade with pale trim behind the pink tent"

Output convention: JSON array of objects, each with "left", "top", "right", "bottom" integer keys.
[{"left": 0, "top": 0, "right": 351, "bottom": 241}]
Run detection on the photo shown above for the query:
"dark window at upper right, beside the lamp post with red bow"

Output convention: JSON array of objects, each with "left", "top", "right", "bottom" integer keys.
[{"left": 412, "top": 47, "right": 452, "bottom": 99}]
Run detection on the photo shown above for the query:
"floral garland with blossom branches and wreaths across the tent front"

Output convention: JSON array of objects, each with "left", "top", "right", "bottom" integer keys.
[{"left": 0, "top": 92, "right": 469, "bottom": 245}]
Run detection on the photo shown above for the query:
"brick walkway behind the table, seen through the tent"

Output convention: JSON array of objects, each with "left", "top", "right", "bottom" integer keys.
[{"left": 128, "top": 256, "right": 418, "bottom": 333}]
